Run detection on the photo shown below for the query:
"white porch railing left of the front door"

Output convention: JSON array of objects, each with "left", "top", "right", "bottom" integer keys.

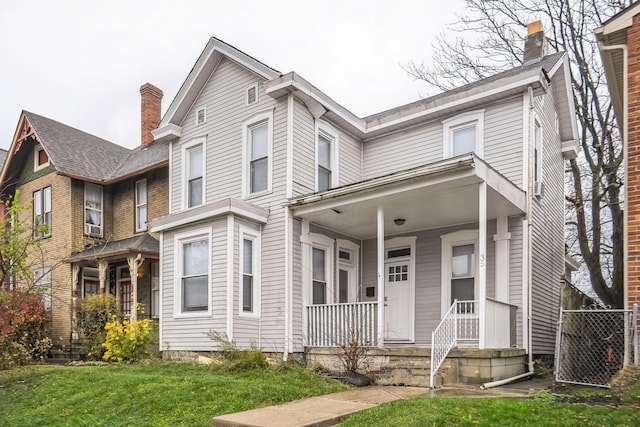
[{"left": 306, "top": 302, "right": 379, "bottom": 347}]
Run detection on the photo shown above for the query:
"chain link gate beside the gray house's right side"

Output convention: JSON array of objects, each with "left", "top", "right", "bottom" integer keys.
[{"left": 554, "top": 306, "right": 637, "bottom": 387}]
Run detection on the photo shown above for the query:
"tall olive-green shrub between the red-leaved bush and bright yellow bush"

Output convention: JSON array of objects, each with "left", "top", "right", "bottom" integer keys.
[{"left": 76, "top": 294, "right": 120, "bottom": 360}]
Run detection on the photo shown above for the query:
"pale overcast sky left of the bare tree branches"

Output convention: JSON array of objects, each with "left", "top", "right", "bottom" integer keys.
[{"left": 0, "top": 0, "right": 463, "bottom": 149}]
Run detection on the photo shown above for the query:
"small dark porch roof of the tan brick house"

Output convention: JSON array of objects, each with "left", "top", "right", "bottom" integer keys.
[{"left": 64, "top": 233, "right": 160, "bottom": 262}]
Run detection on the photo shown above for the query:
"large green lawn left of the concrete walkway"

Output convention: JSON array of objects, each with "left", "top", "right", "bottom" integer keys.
[{"left": 0, "top": 363, "right": 344, "bottom": 426}]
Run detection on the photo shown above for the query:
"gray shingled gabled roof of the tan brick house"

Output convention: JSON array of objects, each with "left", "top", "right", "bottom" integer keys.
[{"left": 0, "top": 111, "right": 169, "bottom": 188}]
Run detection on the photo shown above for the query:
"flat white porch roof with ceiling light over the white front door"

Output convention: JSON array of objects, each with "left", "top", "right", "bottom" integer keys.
[{"left": 285, "top": 153, "right": 526, "bottom": 239}]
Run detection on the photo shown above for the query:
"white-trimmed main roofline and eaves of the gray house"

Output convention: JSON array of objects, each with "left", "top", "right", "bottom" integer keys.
[{"left": 158, "top": 34, "right": 577, "bottom": 147}]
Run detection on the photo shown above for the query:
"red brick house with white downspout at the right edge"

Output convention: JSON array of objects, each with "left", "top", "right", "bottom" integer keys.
[{"left": 595, "top": 3, "right": 640, "bottom": 332}]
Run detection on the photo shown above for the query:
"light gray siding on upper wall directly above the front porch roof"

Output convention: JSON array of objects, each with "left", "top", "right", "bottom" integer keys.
[{"left": 363, "top": 96, "right": 523, "bottom": 186}]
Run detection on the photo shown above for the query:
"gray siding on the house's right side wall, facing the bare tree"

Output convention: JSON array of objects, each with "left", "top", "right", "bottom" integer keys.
[{"left": 531, "top": 91, "right": 564, "bottom": 354}]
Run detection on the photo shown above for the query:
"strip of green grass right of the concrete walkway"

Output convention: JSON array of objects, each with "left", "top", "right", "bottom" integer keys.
[{"left": 340, "top": 397, "right": 640, "bottom": 427}]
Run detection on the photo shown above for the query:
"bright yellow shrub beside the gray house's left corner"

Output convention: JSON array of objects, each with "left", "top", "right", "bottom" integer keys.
[{"left": 102, "top": 316, "right": 157, "bottom": 362}]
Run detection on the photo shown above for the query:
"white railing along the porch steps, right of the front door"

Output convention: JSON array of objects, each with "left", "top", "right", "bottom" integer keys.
[{"left": 429, "top": 301, "right": 480, "bottom": 388}]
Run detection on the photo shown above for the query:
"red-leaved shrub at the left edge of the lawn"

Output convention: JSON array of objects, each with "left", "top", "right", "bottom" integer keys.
[{"left": 0, "top": 291, "right": 52, "bottom": 369}]
